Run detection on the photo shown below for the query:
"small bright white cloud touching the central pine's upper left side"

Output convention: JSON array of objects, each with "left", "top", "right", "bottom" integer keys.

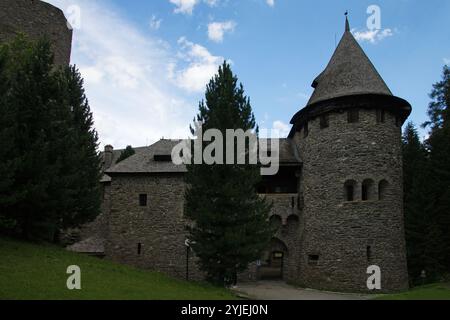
[{"left": 169, "top": 37, "right": 224, "bottom": 93}]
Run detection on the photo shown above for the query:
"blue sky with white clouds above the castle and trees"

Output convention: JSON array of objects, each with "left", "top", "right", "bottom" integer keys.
[{"left": 48, "top": 0, "right": 450, "bottom": 148}]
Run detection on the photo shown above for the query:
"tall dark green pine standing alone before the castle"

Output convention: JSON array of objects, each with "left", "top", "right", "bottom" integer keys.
[{"left": 185, "top": 62, "right": 273, "bottom": 285}]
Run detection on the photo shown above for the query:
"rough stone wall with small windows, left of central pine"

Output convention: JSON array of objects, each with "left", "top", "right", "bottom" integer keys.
[{"left": 105, "top": 174, "right": 203, "bottom": 280}]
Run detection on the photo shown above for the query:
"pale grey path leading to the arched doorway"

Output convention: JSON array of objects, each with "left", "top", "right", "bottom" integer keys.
[{"left": 234, "top": 281, "right": 370, "bottom": 300}]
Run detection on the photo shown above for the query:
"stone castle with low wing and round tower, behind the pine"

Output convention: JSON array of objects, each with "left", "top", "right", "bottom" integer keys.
[{"left": 1, "top": 0, "right": 411, "bottom": 292}]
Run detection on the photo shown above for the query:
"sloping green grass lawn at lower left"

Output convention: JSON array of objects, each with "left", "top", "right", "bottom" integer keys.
[{"left": 0, "top": 238, "right": 236, "bottom": 300}]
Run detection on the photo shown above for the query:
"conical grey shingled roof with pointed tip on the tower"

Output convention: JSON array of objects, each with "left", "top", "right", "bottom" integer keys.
[{"left": 308, "top": 19, "right": 392, "bottom": 105}]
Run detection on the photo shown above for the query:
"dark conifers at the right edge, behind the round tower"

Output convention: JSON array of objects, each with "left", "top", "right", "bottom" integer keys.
[{"left": 403, "top": 66, "right": 450, "bottom": 283}]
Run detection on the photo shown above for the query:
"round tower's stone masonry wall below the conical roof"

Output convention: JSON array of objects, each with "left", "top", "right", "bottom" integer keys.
[{"left": 295, "top": 109, "right": 408, "bottom": 291}]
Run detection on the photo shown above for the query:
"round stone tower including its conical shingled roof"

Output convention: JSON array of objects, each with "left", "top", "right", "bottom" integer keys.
[{"left": 290, "top": 20, "right": 411, "bottom": 292}]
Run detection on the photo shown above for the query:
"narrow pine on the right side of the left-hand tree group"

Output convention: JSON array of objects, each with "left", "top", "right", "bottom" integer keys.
[{"left": 55, "top": 66, "right": 101, "bottom": 229}]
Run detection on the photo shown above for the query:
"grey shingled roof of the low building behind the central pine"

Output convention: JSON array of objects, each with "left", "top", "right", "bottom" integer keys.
[{"left": 103, "top": 139, "right": 300, "bottom": 174}]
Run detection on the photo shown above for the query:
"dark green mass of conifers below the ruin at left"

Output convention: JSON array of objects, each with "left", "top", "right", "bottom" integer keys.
[{"left": 0, "top": 36, "right": 100, "bottom": 240}]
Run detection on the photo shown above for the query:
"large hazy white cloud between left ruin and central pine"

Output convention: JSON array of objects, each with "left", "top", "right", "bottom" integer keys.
[{"left": 49, "top": 0, "right": 204, "bottom": 148}]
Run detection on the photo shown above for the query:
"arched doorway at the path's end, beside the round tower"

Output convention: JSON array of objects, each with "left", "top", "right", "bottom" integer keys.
[{"left": 258, "top": 238, "right": 288, "bottom": 280}]
